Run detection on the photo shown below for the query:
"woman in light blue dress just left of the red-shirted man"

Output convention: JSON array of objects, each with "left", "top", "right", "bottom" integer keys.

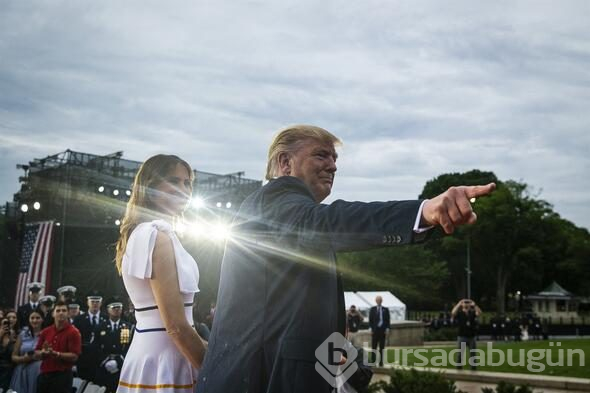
[{"left": 10, "top": 310, "right": 43, "bottom": 393}]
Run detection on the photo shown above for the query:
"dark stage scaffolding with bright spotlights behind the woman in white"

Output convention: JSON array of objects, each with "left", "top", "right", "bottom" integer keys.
[{"left": 4, "top": 150, "right": 262, "bottom": 300}]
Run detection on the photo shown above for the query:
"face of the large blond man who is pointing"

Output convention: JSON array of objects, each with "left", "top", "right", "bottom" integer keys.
[{"left": 283, "top": 139, "right": 338, "bottom": 202}]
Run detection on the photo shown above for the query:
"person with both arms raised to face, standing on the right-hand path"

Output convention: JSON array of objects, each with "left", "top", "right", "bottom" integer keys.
[{"left": 451, "top": 299, "right": 481, "bottom": 370}]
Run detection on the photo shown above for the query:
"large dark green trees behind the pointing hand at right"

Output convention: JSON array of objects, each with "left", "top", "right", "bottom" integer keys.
[{"left": 420, "top": 170, "right": 590, "bottom": 313}]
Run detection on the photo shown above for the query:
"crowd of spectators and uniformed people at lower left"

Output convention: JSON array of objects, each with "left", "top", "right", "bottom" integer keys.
[{"left": 0, "top": 282, "right": 135, "bottom": 393}]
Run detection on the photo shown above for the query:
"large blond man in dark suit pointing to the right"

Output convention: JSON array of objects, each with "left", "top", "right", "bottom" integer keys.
[{"left": 197, "top": 126, "right": 494, "bottom": 393}]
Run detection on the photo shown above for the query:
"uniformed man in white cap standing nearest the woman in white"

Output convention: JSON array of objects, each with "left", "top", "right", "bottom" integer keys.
[{"left": 95, "top": 299, "right": 133, "bottom": 393}]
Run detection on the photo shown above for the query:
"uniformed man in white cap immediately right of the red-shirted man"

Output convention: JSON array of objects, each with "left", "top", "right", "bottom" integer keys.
[{"left": 74, "top": 292, "right": 107, "bottom": 382}]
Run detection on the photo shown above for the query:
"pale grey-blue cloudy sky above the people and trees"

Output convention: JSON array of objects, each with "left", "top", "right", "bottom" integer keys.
[{"left": 0, "top": 0, "right": 590, "bottom": 228}]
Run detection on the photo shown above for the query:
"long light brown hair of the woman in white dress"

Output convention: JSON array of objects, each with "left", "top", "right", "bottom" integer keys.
[{"left": 115, "top": 154, "right": 194, "bottom": 274}]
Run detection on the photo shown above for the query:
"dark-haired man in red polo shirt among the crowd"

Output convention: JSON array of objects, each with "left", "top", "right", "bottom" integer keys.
[{"left": 34, "top": 301, "right": 82, "bottom": 393}]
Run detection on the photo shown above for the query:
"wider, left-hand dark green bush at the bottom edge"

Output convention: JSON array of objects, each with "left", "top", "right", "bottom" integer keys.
[{"left": 367, "top": 369, "right": 462, "bottom": 393}]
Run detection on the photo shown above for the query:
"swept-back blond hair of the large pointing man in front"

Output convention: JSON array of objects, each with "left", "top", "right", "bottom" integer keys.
[{"left": 266, "top": 124, "right": 342, "bottom": 180}]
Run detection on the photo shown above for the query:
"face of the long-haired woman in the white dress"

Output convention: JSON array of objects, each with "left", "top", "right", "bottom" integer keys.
[{"left": 150, "top": 163, "right": 192, "bottom": 216}]
